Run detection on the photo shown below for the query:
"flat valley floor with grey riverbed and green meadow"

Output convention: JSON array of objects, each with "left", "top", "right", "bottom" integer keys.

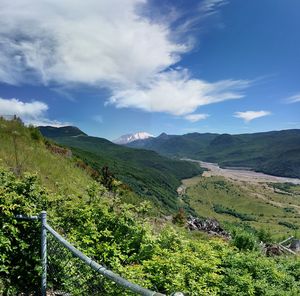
[{"left": 181, "top": 159, "right": 300, "bottom": 239}]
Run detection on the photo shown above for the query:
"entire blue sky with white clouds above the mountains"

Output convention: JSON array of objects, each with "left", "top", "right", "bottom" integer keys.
[{"left": 0, "top": 0, "right": 300, "bottom": 140}]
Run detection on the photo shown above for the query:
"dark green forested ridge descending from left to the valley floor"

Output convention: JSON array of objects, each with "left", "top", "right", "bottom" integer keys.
[{"left": 40, "top": 127, "right": 203, "bottom": 209}]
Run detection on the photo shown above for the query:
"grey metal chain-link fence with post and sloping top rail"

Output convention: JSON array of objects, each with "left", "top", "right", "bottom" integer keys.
[{"left": 16, "top": 211, "right": 183, "bottom": 296}]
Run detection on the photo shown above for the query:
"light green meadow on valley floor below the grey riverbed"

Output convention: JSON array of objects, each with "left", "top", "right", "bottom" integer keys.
[{"left": 184, "top": 177, "right": 300, "bottom": 237}]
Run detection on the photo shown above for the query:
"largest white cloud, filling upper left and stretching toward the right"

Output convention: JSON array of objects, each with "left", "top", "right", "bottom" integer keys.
[{"left": 0, "top": 0, "right": 249, "bottom": 116}]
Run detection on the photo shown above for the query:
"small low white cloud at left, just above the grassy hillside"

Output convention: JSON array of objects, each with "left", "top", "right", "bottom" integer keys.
[{"left": 0, "top": 98, "right": 68, "bottom": 126}]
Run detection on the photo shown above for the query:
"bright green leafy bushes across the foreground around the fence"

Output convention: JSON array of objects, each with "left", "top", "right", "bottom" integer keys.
[{"left": 0, "top": 170, "right": 300, "bottom": 296}]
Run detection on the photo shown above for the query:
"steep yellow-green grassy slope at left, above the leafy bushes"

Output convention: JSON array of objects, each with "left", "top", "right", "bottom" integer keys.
[{"left": 0, "top": 119, "right": 92, "bottom": 195}]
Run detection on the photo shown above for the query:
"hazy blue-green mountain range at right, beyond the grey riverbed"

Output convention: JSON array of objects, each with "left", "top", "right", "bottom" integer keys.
[{"left": 128, "top": 129, "right": 300, "bottom": 178}]
